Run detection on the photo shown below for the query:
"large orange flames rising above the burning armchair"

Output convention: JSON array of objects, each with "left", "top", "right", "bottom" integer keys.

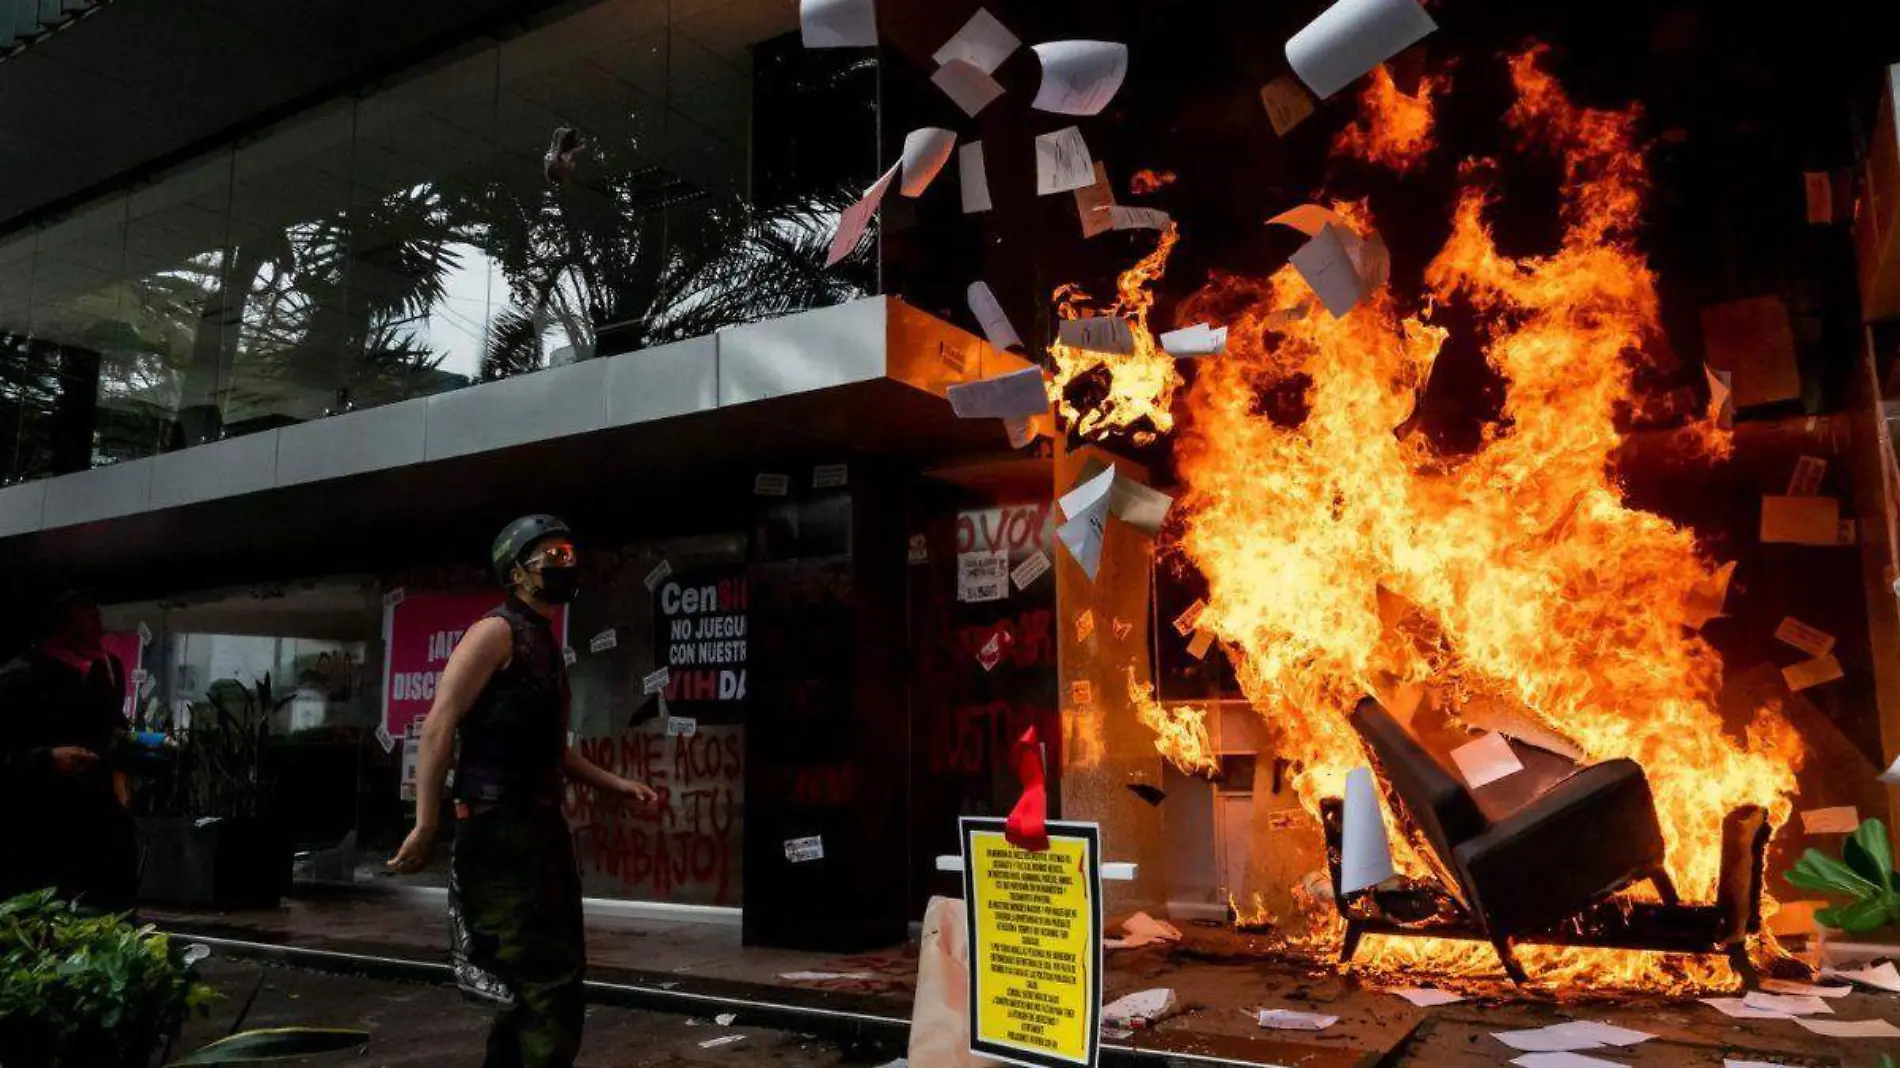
[{"left": 1056, "top": 51, "right": 1801, "bottom": 988}]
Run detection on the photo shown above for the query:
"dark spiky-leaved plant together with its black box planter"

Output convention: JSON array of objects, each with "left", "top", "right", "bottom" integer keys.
[{"left": 137, "top": 677, "right": 291, "bottom": 908}]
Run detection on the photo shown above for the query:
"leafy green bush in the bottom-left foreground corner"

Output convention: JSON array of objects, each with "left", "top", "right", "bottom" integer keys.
[{"left": 0, "top": 889, "right": 369, "bottom": 1068}]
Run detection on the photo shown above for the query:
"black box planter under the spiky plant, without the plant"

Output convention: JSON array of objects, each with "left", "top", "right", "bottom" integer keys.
[{"left": 139, "top": 817, "right": 291, "bottom": 908}]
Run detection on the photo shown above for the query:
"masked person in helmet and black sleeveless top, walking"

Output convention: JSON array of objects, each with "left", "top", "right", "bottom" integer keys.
[{"left": 390, "top": 515, "right": 657, "bottom": 1068}]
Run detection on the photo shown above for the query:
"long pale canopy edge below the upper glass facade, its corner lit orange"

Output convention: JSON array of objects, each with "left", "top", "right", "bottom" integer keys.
[{"left": 0, "top": 294, "right": 1024, "bottom": 538}]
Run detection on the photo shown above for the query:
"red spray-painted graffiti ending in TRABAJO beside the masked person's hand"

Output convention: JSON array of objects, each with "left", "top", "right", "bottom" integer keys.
[{"left": 566, "top": 726, "right": 745, "bottom": 905}]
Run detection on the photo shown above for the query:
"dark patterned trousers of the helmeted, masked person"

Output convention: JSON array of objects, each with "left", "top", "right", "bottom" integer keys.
[{"left": 448, "top": 806, "right": 587, "bottom": 1068}]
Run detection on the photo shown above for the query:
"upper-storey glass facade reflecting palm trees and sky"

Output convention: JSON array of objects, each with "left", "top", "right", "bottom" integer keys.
[{"left": 0, "top": 0, "right": 878, "bottom": 485}]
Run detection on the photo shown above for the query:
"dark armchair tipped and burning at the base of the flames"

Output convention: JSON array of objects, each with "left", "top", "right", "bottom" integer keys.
[{"left": 1322, "top": 697, "right": 1769, "bottom": 982}]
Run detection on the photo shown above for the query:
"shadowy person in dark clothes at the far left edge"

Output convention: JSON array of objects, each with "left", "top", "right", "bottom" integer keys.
[{"left": 0, "top": 593, "right": 139, "bottom": 910}]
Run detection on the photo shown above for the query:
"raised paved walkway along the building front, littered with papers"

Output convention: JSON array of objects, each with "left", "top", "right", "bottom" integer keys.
[{"left": 148, "top": 895, "right": 1900, "bottom": 1068}]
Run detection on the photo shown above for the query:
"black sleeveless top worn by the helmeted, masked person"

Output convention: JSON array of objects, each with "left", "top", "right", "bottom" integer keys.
[{"left": 454, "top": 595, "right": 568, "bottom": 806}]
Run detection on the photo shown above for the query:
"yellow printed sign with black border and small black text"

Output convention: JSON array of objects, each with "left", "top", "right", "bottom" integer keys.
[{"left": 961, "top": 817, "right": 1102, "bottom": 1068}]
